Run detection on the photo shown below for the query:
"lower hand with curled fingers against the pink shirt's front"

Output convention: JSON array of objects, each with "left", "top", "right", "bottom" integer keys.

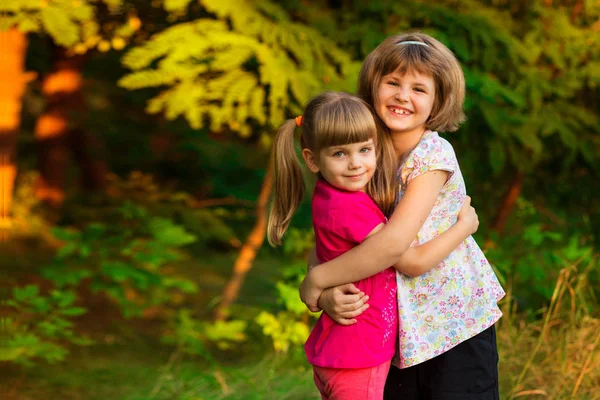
[{"left": 319, "top": 283, "right": 369, "bottom": 325}]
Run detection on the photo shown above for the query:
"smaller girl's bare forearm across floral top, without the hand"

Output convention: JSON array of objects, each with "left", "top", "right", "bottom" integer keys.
[{"left": 394, "top": 223, "right": 471, "bottom": 276}]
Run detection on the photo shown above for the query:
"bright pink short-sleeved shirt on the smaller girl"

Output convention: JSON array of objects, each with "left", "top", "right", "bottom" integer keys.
[{"left": 304, "top": 180, "right": 397, "bottom": 368}]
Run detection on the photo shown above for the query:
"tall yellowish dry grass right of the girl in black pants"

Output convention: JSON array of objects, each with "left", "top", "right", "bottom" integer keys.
[{"left": 498, "top": 262, "right": 600, "bottom": 400}]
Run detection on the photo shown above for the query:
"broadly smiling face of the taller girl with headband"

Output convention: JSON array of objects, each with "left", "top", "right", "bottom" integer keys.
[{"left": 375, "top": 71, "right": 435, "bottom": 137}]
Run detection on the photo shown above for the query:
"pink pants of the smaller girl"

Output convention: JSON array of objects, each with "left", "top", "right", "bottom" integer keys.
[{"left": 313, "top": 361, "right": 390, "bottom": 400}]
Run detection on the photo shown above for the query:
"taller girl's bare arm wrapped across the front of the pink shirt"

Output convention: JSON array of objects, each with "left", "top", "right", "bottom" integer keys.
[{"left": 300, "top": 170, "right": 450, "bottom": 311}]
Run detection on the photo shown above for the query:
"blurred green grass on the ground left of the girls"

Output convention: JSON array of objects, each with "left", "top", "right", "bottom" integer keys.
[{"left": 2, "top": 343, "right": 318, "bottom": 400}]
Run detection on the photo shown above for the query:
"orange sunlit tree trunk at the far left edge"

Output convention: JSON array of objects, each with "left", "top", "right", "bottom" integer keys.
[{"left": 0, "top": 28, "right": 35, "bottom": 231}]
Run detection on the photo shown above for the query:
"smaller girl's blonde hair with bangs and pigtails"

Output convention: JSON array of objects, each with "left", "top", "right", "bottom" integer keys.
[{"left": 267, "top": 92, "right": 396, "bottom": 246}]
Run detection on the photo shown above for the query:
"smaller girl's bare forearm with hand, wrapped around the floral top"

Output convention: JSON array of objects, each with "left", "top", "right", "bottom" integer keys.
[{"left": 394, "top": 196, "right": 479, "bottom": 277}]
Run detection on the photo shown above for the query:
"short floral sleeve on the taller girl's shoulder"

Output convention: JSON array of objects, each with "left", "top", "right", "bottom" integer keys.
[{"left": 401, "top": 132, "right": 458, "bottom": 185}]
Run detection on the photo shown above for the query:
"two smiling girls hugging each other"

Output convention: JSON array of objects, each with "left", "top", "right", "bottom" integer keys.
[{"left": 268, "top": 33, "right": 504, "bottom": 400}]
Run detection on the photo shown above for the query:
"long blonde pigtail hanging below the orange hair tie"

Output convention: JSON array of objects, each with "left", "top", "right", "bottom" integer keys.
[{"left": 267, "top": 119, "right": 304, "bottom": 246}]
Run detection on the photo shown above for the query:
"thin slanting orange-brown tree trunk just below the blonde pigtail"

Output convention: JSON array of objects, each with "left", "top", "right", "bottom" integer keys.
[{"left": 214, "top": 163, "right": 273, "bottom": 321}]
